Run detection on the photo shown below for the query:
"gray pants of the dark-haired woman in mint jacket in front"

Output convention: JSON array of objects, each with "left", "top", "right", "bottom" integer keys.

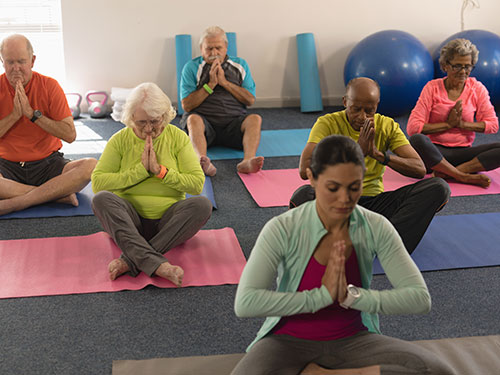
[{"left": 231, "top": 331, "right": 455, "bottom": 375}]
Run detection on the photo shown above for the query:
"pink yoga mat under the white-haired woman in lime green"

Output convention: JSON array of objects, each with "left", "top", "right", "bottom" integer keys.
[{"left": 0, "top": 228, "right": 246, "bottom": 298}]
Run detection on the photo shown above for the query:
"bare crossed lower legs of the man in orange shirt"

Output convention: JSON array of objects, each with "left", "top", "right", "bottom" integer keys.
[{"left": 0, "top": 158, "right": 97, "bottom": 215}]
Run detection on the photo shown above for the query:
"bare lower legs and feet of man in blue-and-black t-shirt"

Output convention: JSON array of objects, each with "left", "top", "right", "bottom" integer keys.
[{"left": 187, "top": 114, "right": 264, "bottom": 176}]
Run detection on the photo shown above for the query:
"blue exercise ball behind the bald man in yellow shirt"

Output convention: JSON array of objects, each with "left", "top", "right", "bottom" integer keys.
[{"left": 344, "top": 30, "right": 434, "bottom": 117}]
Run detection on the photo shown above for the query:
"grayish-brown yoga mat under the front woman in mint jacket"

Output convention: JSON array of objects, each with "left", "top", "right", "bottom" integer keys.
[{"left": 112, "top": 335, "right": 500, "bottom": 375}]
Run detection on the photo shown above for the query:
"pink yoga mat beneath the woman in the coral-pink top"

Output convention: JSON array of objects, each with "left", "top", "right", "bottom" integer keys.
[{"left": 384, "top": 168, "right": 500, "bottom": 197}]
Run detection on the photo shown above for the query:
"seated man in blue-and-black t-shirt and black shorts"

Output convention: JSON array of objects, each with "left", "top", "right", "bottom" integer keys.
[{"left": 180, "top": 26, "right": 264, "bottom": 176}]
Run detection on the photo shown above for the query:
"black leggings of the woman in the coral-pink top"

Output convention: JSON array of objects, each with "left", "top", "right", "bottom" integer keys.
[{"left": 410, "top": 134, "right": 500, "bottom": 173}]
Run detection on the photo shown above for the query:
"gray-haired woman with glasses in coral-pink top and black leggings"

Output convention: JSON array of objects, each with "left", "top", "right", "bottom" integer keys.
[{"left": 407, "top": 39, "right": 500, "bottom": 188}]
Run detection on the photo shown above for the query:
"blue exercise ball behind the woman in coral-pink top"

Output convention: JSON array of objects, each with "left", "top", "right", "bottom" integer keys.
[{"left": 433, "top": 30, "right": 500, "bottom": 107}]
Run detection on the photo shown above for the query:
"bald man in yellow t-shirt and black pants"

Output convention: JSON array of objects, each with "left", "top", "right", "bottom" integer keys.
[{"left": 290, "top": 77, "right": 450, "bottom": 253}]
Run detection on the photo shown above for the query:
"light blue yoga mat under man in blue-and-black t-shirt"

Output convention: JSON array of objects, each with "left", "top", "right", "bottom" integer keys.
[{"left": 207, "top": 129, "right": 311, "bottom": 160}]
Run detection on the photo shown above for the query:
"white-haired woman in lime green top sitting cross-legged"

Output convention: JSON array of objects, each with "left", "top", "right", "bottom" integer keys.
[{"left": 92, "top": 83, "right": 212, "bottom": 286}]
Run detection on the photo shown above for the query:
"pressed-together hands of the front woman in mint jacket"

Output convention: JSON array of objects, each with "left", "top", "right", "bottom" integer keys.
[{"left": 321, "top": 240, "right": 347, "bottom": 303}]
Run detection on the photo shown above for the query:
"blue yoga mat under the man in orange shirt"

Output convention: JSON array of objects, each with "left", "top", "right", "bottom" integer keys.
[{"left": 0, "top": 176, "right": 217, "bottom": 219}]
